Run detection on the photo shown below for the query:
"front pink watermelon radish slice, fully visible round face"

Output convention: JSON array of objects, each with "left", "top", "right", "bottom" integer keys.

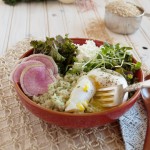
[{"left": 20, "top": 64, "right": 55, "bottom": 96}]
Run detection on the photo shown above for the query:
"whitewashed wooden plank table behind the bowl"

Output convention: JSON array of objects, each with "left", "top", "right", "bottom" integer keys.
[{"left": 0, "top": 0, "right": 150, "bottom": 149}]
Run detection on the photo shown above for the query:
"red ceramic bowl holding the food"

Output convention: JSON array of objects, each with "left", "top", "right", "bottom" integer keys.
[{"left": 14, "top": 38, "right": 144, "bottom": 128}]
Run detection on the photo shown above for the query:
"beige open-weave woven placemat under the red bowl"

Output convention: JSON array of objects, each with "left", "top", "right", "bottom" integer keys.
[{"left": 0, "top": 39, "right": 125, "bottom": 150}]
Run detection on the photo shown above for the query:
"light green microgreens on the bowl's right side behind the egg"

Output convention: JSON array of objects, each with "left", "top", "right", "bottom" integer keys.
[{"left": 70, "top": 43, "right": 141, "bottom": 84}]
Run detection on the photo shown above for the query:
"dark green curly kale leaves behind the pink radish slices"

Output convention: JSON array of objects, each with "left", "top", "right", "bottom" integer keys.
[{"left": 30, "top": 35, "right": 77, "bottom": 75}]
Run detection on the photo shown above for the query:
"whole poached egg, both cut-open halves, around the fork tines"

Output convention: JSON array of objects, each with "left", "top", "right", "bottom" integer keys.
[{"left": 65, "top": 68, "right": 128, "bottom": 112}]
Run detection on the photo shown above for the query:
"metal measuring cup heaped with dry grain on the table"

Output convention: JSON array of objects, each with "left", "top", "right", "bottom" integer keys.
[{"left": 105, "top": 0, "right": 144, "bottom": 34}]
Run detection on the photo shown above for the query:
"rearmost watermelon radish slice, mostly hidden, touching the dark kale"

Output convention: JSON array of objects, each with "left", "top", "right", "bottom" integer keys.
[{"left": 23, "top": 54, "right": 58, "bottom": 76}]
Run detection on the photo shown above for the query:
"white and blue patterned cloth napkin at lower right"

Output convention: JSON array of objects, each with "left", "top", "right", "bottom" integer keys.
[{"left": 119, "top": 98, "right": 147, "bottom": 150}]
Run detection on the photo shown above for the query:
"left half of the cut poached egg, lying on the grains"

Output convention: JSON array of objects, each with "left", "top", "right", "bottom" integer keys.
[{"left": 65, "top": 75, "right": 96, "bottom": 112}]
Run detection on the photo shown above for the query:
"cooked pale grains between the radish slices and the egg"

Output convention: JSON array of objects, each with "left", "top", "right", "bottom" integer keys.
[{"left": 32, "top": 74, "right": 83, "bottom": 111}]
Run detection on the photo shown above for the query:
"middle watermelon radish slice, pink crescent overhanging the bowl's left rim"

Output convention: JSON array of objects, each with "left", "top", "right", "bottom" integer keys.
[{"left": 10, "top": 60, "right": 45, "bottom": 83}]
